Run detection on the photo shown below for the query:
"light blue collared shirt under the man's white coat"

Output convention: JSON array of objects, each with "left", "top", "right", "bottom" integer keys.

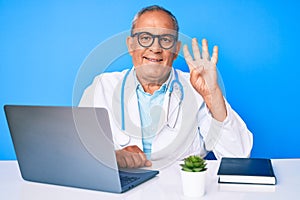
[{"left": 134, "top": 71, "right": 172, "bottom": 159}]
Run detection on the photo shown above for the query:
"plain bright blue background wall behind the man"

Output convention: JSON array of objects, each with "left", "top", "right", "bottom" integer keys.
[{"left": 0, "top": 0, "right": 300, "bottom": 159}]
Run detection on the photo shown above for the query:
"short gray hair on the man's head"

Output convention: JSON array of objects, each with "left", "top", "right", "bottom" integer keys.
[{"left": 131, "top": 5, "right": 179, "bottom": 35}]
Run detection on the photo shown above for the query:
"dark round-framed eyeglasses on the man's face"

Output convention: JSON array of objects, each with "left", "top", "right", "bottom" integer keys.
[{"left": 131, "top": 32, "right": 177, "bottom": 50}]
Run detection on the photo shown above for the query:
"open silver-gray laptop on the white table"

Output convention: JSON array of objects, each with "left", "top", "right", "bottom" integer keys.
[{"left": 4, "top": 105, "right": 158, "bottom": 193}]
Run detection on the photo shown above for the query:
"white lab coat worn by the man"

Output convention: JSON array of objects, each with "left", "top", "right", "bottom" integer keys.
[{"left": 79, "top": 69, "right": 253, "bottom": 160}]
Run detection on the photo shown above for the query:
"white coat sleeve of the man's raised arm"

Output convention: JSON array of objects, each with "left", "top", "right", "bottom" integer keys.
[{"left": 198, "top": 100, "right": 253, "bottom": 159}]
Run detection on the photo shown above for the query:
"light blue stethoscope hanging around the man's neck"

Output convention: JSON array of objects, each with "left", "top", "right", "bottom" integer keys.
[{"left": 121, "top": 69, "right": 184, "bottom": 131}]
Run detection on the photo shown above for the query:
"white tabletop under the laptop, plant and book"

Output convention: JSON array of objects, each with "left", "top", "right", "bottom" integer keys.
[{"left": 0, "top": 159, "right": 300, "bottom": 200}]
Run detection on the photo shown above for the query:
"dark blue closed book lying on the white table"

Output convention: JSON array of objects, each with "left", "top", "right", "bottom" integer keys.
[{"left": 218, "top": 158, "right": 276, "bottom": 185}]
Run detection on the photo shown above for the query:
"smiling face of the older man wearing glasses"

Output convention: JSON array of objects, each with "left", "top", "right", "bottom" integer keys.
[{"left": 127, "top": 11, "right": 180, "bottom": 85}]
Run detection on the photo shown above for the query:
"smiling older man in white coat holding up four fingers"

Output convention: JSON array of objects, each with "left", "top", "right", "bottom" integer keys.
[{"left": 79, "top": 5, "right": 253, "bottom": 168}]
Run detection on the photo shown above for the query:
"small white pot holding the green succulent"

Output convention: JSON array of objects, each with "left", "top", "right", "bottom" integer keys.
[{"left": 180, "top": 170, "right": 206, "bottom": 197}]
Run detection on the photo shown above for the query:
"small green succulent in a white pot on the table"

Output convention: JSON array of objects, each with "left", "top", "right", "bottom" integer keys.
[{"left": 180, "top": 155, "right": 207, "bottom": 197}]
